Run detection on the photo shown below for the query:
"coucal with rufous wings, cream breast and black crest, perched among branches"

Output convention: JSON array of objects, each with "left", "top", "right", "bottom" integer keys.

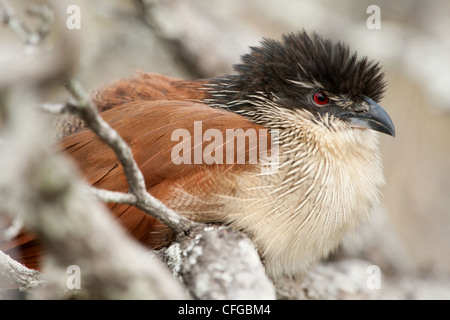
[{"left": 3, "top": 32, "right": 395, "bottom": 278}]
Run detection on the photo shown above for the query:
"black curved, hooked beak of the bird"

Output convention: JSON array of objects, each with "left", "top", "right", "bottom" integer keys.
[{"left": 341, "top": 96, "right": 395, "bottom": 137}]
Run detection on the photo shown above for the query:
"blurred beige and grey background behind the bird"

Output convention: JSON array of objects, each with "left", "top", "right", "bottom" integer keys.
[{"left": 0, "top": 0, "right": 450, "bottom": 298}]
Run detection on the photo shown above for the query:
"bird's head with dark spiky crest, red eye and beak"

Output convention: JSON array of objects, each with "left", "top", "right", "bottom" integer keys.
[{"left": 209, "top": 32, "right": 395, "bottom": 136}]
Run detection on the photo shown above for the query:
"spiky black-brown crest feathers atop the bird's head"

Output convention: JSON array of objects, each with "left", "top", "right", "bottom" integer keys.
[{"left": 209, "top": 31, "right": 385, "bottom": 106}]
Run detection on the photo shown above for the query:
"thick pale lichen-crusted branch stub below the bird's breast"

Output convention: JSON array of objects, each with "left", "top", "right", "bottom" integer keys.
[{"left": 161, "top": 226, "right": 276, "bottom": 300}]
